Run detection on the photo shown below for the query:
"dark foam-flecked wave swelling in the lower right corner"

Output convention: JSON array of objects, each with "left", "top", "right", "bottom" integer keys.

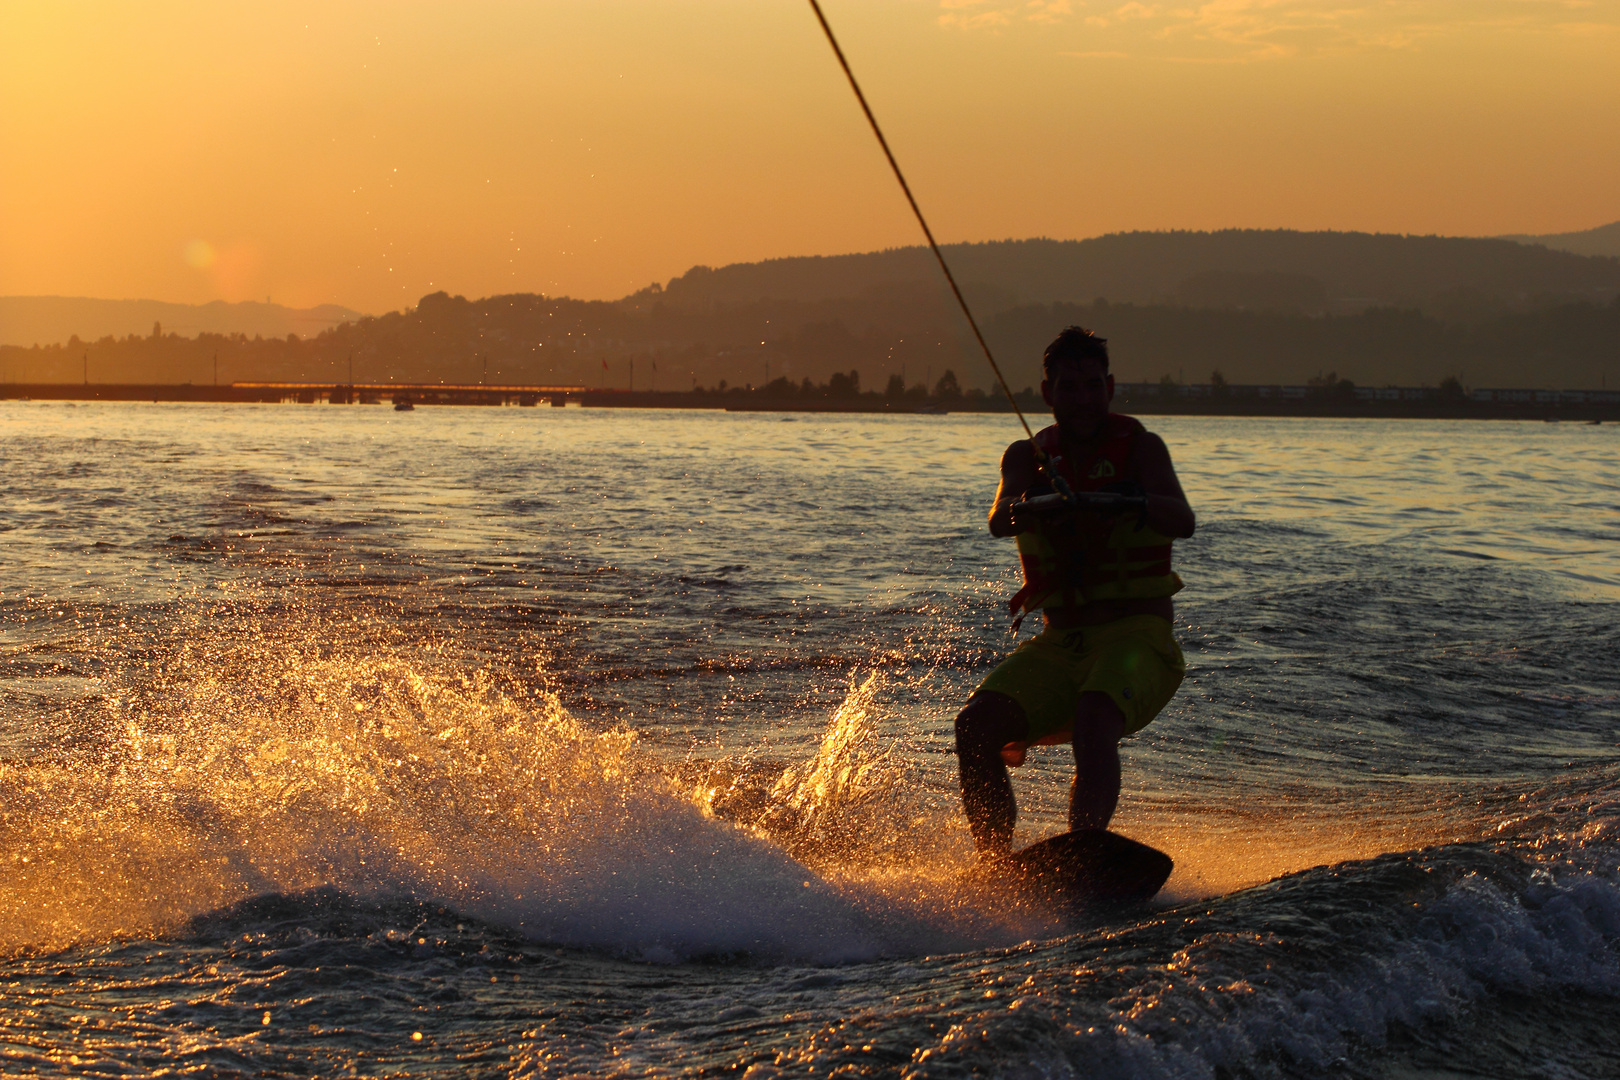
[{"left": 887, "top": 822, "right": 1620, "bottom": 1078}]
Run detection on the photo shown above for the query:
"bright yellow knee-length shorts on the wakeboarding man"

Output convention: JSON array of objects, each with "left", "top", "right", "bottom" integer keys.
[{"left": 974, "top": 615, "right": 1187, "bottom": 743}]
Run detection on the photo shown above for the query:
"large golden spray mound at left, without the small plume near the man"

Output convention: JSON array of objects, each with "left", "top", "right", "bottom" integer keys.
[{"left": 0, "top": 634, "right": 939, "bottom": 960}]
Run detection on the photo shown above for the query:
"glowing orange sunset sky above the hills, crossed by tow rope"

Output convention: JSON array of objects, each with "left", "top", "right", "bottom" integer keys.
[{"left": 0, "top": 0, "right": 1620, "bottom": 311}]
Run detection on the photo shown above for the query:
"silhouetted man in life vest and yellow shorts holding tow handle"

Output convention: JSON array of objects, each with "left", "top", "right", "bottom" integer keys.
[{"left": 956, "top": 327, "right": 1196, "bottom": 858}]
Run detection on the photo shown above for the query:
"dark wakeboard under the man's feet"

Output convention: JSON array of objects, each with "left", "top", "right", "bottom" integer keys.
[{"left": 996, "top": 829, "right": 1175, "bottom": 910}]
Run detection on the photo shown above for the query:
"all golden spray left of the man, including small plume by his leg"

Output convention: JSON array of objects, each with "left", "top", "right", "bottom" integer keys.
[{"left": 0, "top": 610, "right": 1075, "bottom": 962}]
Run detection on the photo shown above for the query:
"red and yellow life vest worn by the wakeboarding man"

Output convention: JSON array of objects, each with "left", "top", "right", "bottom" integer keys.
[{"left": 1008, "top": 413, "right": 1183, "bottom": 627}]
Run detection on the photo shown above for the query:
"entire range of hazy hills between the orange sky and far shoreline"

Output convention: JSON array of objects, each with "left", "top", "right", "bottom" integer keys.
[{"left": 0, "top": 230, "right": 1620, "bottom": 390}]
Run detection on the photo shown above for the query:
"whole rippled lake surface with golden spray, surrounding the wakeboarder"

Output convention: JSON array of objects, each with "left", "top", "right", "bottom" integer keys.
[{"left": 0, "top": 403, "right": 1620, "bottom": 1080}]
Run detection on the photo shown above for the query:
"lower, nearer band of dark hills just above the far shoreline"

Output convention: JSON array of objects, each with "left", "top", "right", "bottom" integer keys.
[{"left": 0, "top": 293, "right": 1620, "bottom": 390}]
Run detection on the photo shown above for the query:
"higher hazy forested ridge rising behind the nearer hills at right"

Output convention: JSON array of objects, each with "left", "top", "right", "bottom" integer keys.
[{"left": 644, "top": 230, "right": 1620, "bottom": 321}]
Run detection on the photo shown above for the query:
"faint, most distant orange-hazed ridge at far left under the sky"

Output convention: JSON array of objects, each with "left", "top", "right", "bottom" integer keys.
[{"left": 0, "top": 296, "right": 361, "bottom": 347}]
